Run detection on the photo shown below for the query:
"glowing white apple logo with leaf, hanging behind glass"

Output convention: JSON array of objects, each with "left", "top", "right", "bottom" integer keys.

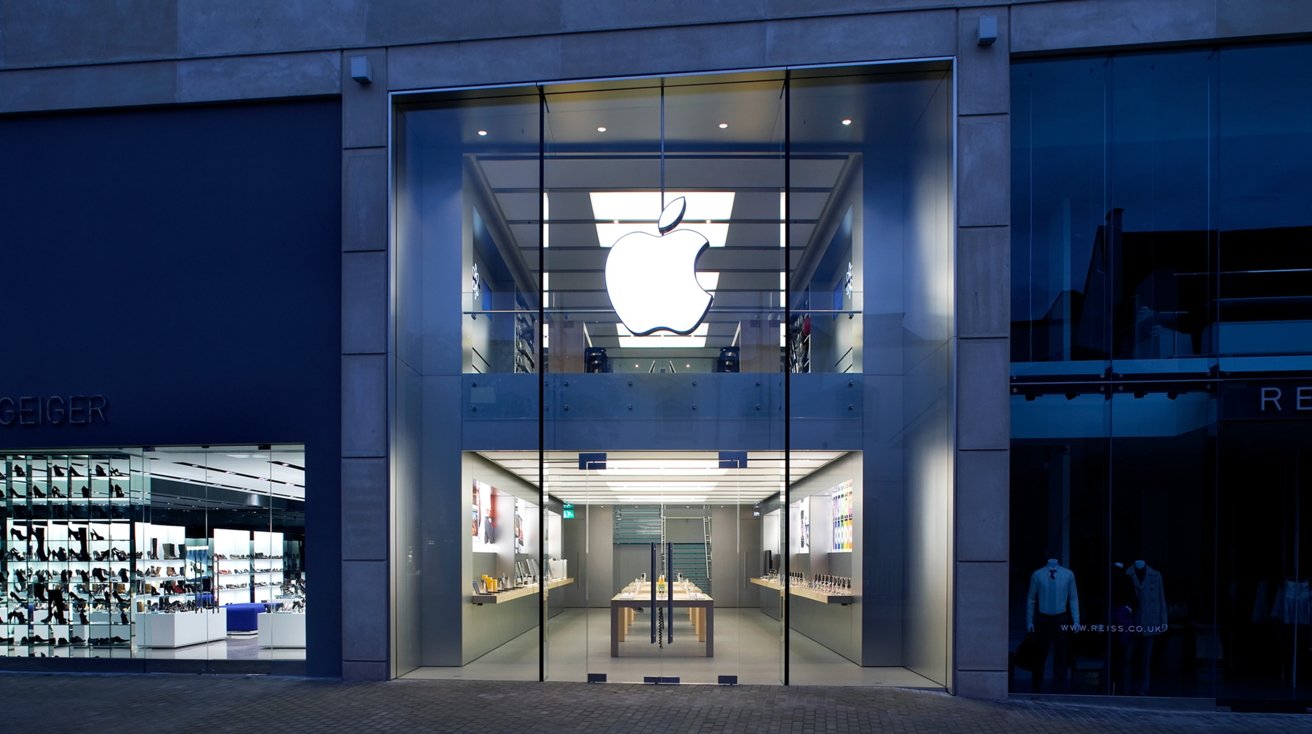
[{"left": 606, "top": 197, "right": 715, "bottom": 336}]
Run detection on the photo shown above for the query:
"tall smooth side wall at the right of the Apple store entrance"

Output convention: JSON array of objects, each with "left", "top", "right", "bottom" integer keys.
[{"left": 862, "top": 68, "right": 954, "bottom": 683}]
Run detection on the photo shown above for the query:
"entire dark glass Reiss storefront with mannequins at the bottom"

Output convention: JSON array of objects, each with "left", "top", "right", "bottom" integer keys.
[{"left": 1010, "top": 45, "right": 1312, "bottom": 705}]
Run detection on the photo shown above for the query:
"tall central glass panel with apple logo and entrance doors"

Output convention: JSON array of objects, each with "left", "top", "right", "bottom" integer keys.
[{"left": 543, "top": 75, "right": 785, "bottom": 683}]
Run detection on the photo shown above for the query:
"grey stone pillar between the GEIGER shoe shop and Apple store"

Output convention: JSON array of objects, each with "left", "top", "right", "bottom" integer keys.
[{"left": 341, "top": 50, "right": 392, "bottom": 680}]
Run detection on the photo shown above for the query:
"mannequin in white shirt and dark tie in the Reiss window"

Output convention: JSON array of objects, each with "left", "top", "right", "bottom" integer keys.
[{"left": 1025, "top": 558, "right": 1080, "bottom": 692}]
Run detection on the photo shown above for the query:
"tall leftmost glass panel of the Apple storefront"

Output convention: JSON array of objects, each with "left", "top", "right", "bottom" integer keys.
[{"left": 392, "top": 89, "right": 547, "bottom": 680}]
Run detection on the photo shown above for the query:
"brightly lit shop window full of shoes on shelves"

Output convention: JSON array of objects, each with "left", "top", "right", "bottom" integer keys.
[{"left": 0, "top": 445, "right": 306, "bottom": 672}]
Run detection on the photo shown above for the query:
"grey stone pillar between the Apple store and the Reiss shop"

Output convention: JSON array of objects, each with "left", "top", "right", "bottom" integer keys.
[{"left": 951, "top": 7, "right": 1012, "bottom": 699}]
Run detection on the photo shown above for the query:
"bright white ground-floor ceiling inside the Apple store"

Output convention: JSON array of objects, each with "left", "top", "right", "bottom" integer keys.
[{"left": 480, "top": 452, "right": 844, "bottom": 504}]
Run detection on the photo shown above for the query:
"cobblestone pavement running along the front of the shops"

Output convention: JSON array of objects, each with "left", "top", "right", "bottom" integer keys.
[{"left": 0, "top": 674, "right": 1312, "bottom": 734}]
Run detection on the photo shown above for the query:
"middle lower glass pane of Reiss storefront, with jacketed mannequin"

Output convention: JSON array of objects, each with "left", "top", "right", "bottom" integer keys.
[{"left": 1112, "top": 389, "right": 1220, "bottom": 696}]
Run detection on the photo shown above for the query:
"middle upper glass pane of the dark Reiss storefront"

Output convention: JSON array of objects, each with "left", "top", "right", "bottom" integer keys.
[{"left": 1107, "top": 51, "right": 1215, "bottom": 372}]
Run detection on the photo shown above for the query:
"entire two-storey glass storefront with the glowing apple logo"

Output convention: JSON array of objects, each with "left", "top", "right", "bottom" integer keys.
[{"left": 392, "top": 64, "right": 953, "bottom": 688}]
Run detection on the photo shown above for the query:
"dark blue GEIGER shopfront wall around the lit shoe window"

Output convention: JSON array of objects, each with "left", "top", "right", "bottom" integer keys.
[{"left": 0, "top": 100, "right": 341, "bottom": 676}]
